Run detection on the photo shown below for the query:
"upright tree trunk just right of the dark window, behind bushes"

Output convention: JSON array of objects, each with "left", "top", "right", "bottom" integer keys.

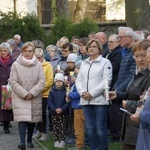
[{"left": 56, "top": 0, "right": 70, "bottom": 17}]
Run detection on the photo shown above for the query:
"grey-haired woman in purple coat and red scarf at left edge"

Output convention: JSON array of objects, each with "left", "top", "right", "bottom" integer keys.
[{"left": 0, "top": 42, "right": 14, "bottom": 134}]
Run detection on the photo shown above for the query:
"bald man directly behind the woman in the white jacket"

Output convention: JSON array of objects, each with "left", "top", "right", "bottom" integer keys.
[{"left": 95, "top": 32, "right": 109, "bottom": 57}]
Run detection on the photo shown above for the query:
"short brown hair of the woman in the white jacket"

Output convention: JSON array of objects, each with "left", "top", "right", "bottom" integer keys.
[{"left": 86, "top": 39, "right": 103, "bottom": 55}]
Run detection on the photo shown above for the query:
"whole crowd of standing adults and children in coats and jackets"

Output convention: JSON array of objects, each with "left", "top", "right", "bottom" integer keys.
[{"left": 0, "top": 27, "right": 150, "bottom": 150}]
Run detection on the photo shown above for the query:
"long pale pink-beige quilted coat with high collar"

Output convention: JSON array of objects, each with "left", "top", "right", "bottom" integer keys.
[{"left": 9, "top": 55, "right": 45, "bottom": 122}]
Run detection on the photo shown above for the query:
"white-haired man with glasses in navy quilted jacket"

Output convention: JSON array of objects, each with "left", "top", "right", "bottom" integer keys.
[{"left": 113, "top": 27, "right": 136, "bottom": 92}]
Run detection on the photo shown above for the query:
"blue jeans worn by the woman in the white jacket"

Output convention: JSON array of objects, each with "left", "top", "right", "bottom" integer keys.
[{"left": 83, "top": 105, "right": 109, "bottom": 150}]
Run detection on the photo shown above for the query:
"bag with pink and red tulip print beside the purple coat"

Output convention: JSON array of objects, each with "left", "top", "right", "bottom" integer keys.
[{"left": 1, "top": 83, "right": 12, "bottom": 110}]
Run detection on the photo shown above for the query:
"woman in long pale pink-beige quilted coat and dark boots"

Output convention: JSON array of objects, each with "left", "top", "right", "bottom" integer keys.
[{"left": 9, "top": 42, "right": 45, "bottom": 150}]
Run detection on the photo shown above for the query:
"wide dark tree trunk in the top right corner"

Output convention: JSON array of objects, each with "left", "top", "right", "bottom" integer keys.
[{"left": 125, "top": 0, "right": 150, "bottom": 30}]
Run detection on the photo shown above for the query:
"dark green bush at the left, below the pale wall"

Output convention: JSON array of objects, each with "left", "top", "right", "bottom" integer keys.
[{"left": 0, "top": 12, "right": 45, "bottom": 42}]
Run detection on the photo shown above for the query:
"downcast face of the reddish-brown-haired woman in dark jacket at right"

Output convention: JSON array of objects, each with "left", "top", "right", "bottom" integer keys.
[{"left": 134, "top": 49, "right": 148, "bottom": 70}]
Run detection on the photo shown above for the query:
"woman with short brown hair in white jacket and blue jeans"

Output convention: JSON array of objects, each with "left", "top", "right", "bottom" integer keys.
[{"left": 76, "top": 39, "right": 112, "bottom": 150}]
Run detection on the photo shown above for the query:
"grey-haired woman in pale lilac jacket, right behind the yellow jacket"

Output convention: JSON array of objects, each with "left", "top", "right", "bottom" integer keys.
[{"left": 46, "top": 45, "right": 59, "bottom": 70}]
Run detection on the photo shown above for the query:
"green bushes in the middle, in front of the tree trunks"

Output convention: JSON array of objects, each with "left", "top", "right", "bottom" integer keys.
[{"left": 49, "top": 17, "right": 98, "bottom": 44}]
